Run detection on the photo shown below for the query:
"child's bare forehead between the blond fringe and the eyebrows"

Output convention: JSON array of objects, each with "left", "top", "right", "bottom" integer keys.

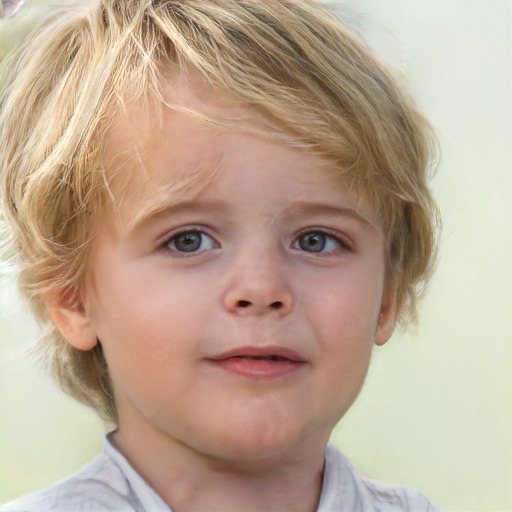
[{"left": 104, "top": 81, "right": 376, "bottom": 229}]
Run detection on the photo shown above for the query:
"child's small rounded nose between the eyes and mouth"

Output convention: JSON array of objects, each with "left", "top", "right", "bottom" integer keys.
[{"left": 223, "top": 249, "right": 295, "bottom": 316}]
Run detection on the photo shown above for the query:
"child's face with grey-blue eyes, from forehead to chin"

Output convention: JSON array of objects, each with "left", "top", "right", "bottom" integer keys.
[{"left": 71, "top": 87, "right": 394, "bottom": 460}]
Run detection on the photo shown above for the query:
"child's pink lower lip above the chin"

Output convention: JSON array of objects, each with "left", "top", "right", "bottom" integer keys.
[{"left": 207, "top": 357, "right": 305, "bottom": 380}]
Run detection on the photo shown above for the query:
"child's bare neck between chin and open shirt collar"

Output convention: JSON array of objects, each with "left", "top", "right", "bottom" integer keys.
[{"left": 113, "top": 429, "right": 325, "bottom": 512}]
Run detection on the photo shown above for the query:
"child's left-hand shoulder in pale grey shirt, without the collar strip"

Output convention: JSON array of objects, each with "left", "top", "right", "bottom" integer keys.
[{"left": 1, "top": 453, "right": 139, "bottom": 512}]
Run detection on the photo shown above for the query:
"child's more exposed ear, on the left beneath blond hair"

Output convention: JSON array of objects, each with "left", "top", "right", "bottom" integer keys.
[{"left": 44, "top": 289, "right": 98, "bottom": 350}]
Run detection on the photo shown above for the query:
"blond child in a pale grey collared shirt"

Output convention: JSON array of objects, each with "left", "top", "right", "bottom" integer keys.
[{"left": 0, "top": 0, "right": 437, "bottom": 512}]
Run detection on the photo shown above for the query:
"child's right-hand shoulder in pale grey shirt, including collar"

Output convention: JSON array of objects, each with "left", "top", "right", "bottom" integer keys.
[{"left": 318, "top": 445, "right": 441, "bottom": 512}]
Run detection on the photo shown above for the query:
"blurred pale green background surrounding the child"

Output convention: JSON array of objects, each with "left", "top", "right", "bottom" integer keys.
[{"left": 0, "top": 0, "right": 512, "bottom": 512}]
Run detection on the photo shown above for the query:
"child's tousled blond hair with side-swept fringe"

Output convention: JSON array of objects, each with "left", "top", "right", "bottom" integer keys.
[{"left": 0, "top": 0, "right": 437, "bottom": 422}]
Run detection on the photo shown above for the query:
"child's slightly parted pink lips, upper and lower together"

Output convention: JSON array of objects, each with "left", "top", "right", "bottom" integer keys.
[{"left": 208, "top": 346, "right": 307, "bottom": 380}]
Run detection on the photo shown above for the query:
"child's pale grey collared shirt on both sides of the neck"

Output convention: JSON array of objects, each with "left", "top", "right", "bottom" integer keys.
[{"left": 0, "top": 437, "right": 440, "bottom": 512}]
